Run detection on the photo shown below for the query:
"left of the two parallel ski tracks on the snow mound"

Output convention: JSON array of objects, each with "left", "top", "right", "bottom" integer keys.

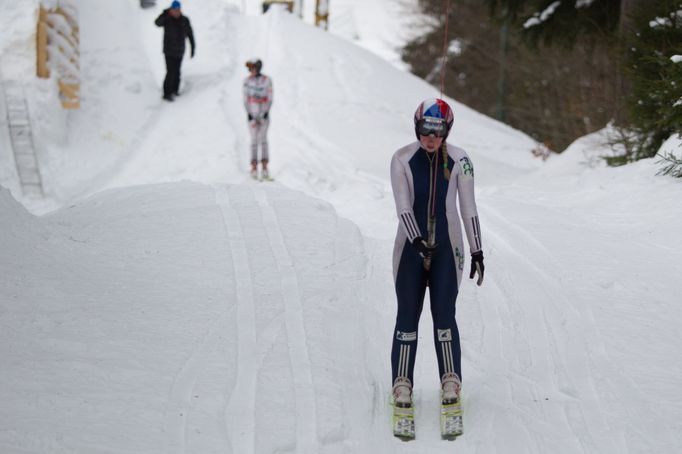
[{"left": 214, "top": 187, "right": 258, "bottom": 454}]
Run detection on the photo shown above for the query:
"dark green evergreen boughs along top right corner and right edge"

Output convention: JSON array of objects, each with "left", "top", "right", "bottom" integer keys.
[{"left": 488, "top": 0, "right": 682, "bottom": 170}]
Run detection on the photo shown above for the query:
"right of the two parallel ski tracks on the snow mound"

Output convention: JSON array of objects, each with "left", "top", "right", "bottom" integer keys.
[{"left": 253, "top": 188, "right": 320, "bottom": 454}]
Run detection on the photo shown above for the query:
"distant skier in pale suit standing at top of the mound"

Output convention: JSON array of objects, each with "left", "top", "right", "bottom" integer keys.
[{"left": 243, "top": 59, "right": 272, "bottom": 178}]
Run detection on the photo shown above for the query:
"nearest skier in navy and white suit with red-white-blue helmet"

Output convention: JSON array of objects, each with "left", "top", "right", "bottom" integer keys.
[{"left": 391, "top": 99, "right": 484, "bottom": 406}]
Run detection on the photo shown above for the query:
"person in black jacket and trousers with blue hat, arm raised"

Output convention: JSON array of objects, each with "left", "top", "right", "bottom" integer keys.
[{"left": 154, "top": 0, "right": 196, "bottom": 101}]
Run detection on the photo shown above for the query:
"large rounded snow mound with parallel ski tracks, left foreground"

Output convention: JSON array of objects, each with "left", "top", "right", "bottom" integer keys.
[{"left": 0, "top": 183, "right": 372, "bottom": 453}]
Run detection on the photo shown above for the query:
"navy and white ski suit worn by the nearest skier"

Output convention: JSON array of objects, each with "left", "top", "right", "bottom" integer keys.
[{"left": 391, "top": 142, "right": 482, "bottom": 383}]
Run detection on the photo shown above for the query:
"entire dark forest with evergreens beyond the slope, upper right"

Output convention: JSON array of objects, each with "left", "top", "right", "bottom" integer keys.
[{"left": 403, "top": 0, "right": 682, "bottom": 171}]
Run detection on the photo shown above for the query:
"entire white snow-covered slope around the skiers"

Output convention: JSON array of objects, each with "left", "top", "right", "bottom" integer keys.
[{"left": 0, "top": 0, "right": 682, "bottom": 454}]
